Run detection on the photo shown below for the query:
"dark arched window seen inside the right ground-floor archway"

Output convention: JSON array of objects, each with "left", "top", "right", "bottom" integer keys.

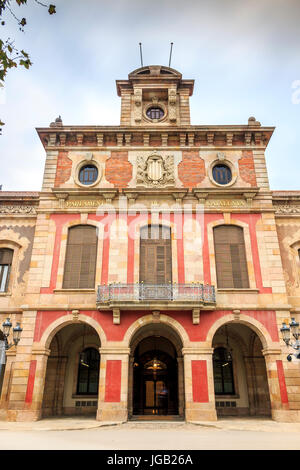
[{"left": 213, "top": 348, "right": 235, "bottom": 395}]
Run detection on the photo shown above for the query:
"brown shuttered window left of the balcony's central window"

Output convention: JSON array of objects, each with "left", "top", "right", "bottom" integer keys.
[{"left": 63, "top": 225, "right": 97, "bottom": 289}]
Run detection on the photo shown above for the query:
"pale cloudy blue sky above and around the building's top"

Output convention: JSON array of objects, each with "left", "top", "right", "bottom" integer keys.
[{"left": 0, "top": 0, "right": 300, "bottom": 191}]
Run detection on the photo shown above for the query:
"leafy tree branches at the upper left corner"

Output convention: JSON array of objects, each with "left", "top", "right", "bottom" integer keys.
[{"left": 0, "top": 0, "right": 56, "bottom": 135}]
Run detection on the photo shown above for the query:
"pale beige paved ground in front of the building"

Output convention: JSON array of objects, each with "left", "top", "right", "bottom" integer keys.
[{"left": 0, "top": 418, "right": 300, "bottom": 450}]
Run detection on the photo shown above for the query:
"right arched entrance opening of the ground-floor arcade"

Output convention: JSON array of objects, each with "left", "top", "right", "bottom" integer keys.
[{"left": 213, "top": 322, "right": 271, "bottom": 416}]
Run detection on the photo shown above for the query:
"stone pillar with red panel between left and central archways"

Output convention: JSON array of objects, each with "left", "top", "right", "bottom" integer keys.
[{"left": 97, "top": 346, "right": 130, "bottom": 422}]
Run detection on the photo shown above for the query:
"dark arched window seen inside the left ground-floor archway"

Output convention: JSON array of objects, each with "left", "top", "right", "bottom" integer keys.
[{"left": 77, "top": 348, "right": 100, "bottom": 395}]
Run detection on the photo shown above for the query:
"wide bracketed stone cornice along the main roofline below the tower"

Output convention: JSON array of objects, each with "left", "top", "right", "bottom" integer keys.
[{"left": 36, "top": 124, "right": 274, "bottom": 150}]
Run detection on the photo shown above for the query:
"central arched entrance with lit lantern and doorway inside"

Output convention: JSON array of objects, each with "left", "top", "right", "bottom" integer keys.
[{"left": 129, "top": 324, "right": 184, "bottom": 419}]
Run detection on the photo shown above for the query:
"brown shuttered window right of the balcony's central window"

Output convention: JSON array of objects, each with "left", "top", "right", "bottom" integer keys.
[{"left": 214, "top": 225, "right": 249, "bottom": 289}]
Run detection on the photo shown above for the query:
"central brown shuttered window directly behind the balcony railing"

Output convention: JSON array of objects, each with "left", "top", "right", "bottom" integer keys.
[{"left": 140, "top": 225, "right": 172, "bottom": 284}]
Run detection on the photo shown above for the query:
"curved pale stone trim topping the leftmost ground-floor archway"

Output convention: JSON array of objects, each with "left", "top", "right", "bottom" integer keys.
[{"left": 35, "top": 314, "right": 106, "bottom": 349}]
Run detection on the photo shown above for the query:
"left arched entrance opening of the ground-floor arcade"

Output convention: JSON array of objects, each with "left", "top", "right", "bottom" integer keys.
[{"left": 42, "top": 322, "right": 100, "bottom": 417}]
